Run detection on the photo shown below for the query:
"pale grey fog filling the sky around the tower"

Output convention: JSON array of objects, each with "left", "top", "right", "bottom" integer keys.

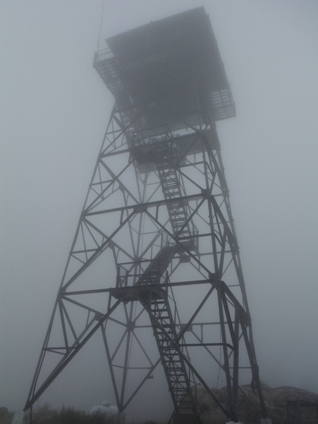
[{"left": 0, "top": 0, "right": 318, "bottom": 420}]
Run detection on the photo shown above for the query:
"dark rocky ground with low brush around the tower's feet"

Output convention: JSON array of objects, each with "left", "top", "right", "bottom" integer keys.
[{"left": 0, "top": 385, "right": 318, "bottom": 424}]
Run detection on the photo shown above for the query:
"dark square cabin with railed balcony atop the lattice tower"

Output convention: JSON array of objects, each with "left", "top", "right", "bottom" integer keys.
[{"left": 94, "top": 7, "right": 235, "bottom": 126}]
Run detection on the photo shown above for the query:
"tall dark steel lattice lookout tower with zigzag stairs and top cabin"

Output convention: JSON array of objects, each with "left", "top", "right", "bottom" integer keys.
[{"left": 25, "top": 8, "right": 266, "bottom": 423}]
